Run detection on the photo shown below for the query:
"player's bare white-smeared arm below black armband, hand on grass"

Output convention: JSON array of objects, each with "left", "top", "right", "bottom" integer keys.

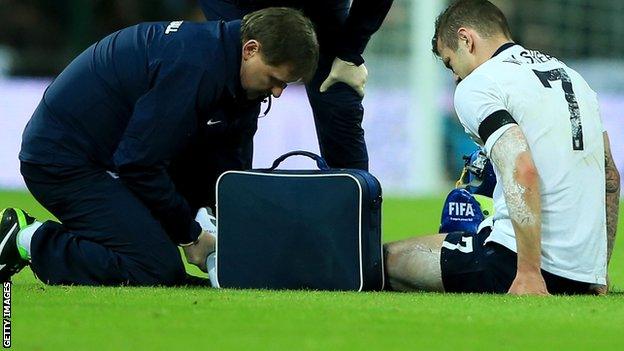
[{"left": 490, "top": 125, "right": 548, "bottom": 295}]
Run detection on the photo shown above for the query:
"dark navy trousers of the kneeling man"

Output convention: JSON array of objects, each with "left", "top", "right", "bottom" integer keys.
[{"left": 21, "top": 163, "right": 185, "bottom": 285}]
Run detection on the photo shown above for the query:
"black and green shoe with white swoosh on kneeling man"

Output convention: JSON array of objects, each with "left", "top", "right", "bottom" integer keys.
[{"left": 0, "top": 208, "right": 35, "bottom": 282}]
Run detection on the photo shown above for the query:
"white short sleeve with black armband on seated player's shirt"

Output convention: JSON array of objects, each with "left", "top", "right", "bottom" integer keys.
[{"left": 455, "top": 73, "right": 517, "bottom": 155}]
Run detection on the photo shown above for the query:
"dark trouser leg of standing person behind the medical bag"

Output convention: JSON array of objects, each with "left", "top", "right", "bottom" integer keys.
[{"left": 306, "top": 53, "right": 368, "bottom": 170}]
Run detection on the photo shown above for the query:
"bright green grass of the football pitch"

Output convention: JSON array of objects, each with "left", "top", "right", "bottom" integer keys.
[{"left": 0, "top": 191, "right": 624, "bottom": 351}]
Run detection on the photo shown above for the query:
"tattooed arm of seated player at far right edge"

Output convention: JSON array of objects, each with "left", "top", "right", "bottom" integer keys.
[{"left": 603, "top": 132, "right": 620, "bottom": 262}]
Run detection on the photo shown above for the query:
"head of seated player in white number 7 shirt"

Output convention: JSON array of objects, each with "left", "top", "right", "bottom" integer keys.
[{"left": 431, "top": 0, "right": 511, "bottom": 79}]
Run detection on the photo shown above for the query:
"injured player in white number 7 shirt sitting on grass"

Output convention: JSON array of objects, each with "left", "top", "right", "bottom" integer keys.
[{"left": 385, "top": 0, "right": 619, "bottom": 295}]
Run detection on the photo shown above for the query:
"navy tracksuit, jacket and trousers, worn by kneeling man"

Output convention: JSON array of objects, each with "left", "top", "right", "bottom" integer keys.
[{"left": 19, "top": 21, "right": 259, "bottom": 285}]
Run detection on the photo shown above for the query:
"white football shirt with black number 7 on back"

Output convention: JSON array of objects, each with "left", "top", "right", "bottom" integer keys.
[{"left": 455, "top": 44, "right": 607, "bottom": 284}]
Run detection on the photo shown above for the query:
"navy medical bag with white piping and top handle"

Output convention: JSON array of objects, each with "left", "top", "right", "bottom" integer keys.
[{"left": 216, "top": 151, "right": 384, "bottom": 291}]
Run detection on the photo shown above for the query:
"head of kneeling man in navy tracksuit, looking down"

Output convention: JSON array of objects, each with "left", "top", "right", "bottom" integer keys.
[{"left": 241, "top": 7, "right": 319, "bottom": 98}]
